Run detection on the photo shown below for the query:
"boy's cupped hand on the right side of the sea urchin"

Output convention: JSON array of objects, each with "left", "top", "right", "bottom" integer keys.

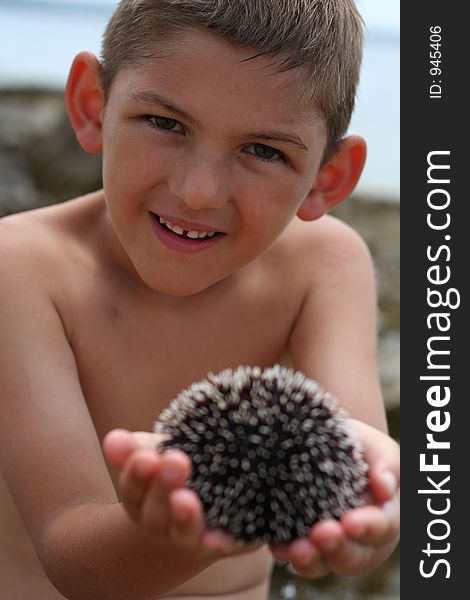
[{"left": 271, "top": 420, "right": 400, "bottom": 578}]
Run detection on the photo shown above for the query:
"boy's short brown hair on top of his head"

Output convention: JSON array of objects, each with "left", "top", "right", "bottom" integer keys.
[{"left": 101, "top": 0, "right": 362, "bottom": 161}]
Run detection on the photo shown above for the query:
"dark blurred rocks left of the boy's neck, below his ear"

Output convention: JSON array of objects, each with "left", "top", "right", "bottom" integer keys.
[{"left": 0, "top": 90, "right": 101, "bottom": 216}]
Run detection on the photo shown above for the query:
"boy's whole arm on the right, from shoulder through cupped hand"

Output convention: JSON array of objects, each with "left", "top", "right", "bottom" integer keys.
[{"left": 280, "top": 219, "right": 399, "bottom": 577}]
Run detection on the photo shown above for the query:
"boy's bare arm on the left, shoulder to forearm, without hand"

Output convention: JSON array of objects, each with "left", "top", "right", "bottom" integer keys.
[{"left": 0, "top": 233, "right": 224, "bottom": 600}]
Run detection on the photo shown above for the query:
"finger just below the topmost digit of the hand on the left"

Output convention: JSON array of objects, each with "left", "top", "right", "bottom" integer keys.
[{"left": 119, "top": 449, "right": 162, "bottom": 521}]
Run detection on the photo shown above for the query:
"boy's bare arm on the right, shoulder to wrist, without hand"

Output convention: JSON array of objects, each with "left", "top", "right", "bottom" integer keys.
[{"left": 289, "top": 217, "right": 386, "bottom": 431}]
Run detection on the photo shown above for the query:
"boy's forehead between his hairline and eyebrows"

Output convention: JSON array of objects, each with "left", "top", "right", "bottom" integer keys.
[{"left": 112, "top": 28, "right": 324, "bottom": 129}]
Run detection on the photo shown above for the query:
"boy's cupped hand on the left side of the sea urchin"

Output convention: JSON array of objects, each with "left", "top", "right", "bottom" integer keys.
[{"left": 103, "top": 429, "right": 255, "bottom": 557}]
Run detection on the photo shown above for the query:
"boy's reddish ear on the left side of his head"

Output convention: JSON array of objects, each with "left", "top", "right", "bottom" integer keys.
[{"left": 65, "top": 52, "right": 104, "bottom": 153}]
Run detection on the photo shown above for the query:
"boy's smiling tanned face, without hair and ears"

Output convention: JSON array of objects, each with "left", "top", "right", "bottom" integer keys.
[{"left": 102, "top": 30, "right": 326, "bottom": 296}]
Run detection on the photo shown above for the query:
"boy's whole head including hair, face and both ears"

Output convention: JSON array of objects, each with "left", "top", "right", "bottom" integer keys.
[{"left": 66, "top": 0, "right": 365, "bottom": 295}]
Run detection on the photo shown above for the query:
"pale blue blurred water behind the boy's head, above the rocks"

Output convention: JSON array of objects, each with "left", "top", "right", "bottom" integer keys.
[{"left": 0, "top": 0, "right": 400, "bottom": 199}]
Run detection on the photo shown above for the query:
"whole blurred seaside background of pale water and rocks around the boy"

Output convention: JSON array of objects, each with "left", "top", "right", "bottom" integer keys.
[{"left": 0, "top": 0, "right": 400, "bottom": 600}]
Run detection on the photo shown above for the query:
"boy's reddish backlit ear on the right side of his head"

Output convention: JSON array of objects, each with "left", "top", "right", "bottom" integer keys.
[{"left": 297, "top": 135, "right": 367, "bottom": 221}]
